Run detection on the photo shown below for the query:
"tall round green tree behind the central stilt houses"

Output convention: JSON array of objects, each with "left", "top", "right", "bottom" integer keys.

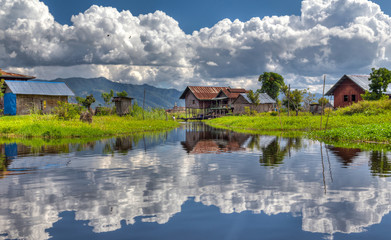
[{"left": 258, "top": 72, "right": 285, "bottom": 100}]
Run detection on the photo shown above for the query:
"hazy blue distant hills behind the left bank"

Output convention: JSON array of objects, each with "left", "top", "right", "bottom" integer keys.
[{"left": 36, "top": 77, "right": 184, "bottom": 108}]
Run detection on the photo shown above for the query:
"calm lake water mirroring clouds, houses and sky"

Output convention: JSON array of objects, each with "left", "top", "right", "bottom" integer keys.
[{"left": 0, "top": 124, "right": 391, "bottom": 240}]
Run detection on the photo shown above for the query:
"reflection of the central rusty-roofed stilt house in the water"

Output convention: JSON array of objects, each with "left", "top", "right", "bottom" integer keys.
[{"left": 182, "top": 124, "right": 250, "bottom": 154}]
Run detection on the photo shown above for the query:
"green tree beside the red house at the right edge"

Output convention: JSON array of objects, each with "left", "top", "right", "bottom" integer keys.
[{"left": 361, "top": 68, "right": 391, "bottom": 100}]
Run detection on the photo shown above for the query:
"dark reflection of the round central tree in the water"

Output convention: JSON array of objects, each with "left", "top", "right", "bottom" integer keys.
[{"left": 259, "top": 137, "right": 302, "bottom": 167}]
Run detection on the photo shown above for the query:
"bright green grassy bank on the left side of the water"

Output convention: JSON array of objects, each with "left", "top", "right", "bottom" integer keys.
[{"left": 0, "top": 115, "right": 179, "bottom": 138}]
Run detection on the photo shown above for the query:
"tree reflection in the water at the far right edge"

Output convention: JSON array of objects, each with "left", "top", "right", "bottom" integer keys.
[{"left": 369, "top": 151, "right": 391, "bottom": 177}]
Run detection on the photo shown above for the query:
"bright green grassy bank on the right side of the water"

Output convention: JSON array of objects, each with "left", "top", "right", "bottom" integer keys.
[{"left": 207, "top": 101, "right": 391, "bottom": 144}]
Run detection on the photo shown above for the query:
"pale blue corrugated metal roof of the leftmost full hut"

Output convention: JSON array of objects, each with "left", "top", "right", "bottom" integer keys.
[{"left": 5, "top": 80, "right": 75, "bottom": 96}]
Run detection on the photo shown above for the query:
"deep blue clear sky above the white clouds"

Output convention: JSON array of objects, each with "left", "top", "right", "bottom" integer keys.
[{"left": 43, "top": 0, "right": 391, "bottom": 33}]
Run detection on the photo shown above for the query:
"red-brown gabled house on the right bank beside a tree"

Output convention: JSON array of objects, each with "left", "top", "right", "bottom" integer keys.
[{"left": 325, "top": 75, "right": 369, "bottom": 108}]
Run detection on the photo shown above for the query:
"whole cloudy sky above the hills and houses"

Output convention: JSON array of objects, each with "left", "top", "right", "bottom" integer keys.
[{"left": 0, "top": 0, "right": 391, "bottom": 92}]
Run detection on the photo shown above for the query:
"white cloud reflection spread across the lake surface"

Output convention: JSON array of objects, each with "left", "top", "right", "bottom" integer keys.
[{"left": 0, "top": 137, "right": 391, "bottom": 239}]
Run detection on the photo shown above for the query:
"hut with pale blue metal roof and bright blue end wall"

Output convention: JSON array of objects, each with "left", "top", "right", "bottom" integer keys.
[{"left": 4, "top": 80, "right": 75, "bottom": 115}]
